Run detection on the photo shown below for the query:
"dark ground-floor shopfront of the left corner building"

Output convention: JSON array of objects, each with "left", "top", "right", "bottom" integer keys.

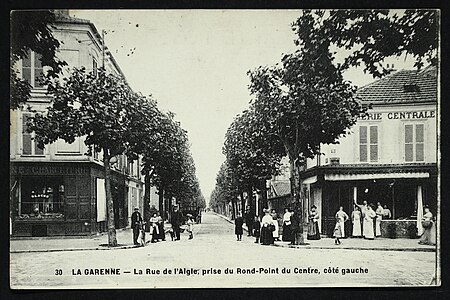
[{"left": 10, "top": 162, "right": 136, "bottom": 236}]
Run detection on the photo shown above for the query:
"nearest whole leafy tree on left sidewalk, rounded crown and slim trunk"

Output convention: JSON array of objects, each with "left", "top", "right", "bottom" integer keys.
[{"left": 29, "top": 68, "right": 147, "bottom": 247}]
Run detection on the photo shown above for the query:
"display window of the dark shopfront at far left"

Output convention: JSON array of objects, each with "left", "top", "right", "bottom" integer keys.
[{"left": 19, "top": 177, "right": 64, "bottom": 218}]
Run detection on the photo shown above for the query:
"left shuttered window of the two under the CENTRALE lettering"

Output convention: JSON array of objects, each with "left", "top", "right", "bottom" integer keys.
[{"left": 359, "top": 125, "right": 378, "bottom": 162}]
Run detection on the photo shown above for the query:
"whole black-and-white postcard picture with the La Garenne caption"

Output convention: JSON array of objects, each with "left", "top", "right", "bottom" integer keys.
[{"left": 5, "top": 8, "right": 442, "bottom": 290}]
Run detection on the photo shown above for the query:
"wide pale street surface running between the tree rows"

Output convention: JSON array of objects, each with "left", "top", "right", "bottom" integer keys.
[{"left": 10, "top": 213, "right": 436, "bottom": 288}]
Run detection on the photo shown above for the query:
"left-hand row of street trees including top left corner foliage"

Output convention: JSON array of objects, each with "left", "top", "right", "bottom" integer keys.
[{"left": 10, "top": 11, "right": 205, "bottom": 246}]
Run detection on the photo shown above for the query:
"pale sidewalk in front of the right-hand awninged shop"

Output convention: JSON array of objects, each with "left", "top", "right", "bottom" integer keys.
[{"left": 216, "top": 214, "right": 436, "bottom": 252}]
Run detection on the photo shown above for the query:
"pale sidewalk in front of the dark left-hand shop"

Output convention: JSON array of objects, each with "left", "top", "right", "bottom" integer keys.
[{"left": 10, "top": 228, "right": 142, "bottom": 253}]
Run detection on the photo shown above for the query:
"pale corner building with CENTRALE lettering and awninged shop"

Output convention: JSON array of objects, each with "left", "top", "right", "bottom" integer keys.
[{"left": 300, "top": 67, "right": 438, "bottom": 237}]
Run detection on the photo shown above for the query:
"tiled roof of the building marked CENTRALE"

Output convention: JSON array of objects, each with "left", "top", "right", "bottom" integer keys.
[{"left": 356, "top": 66, "right": 437, "bottom": 104}]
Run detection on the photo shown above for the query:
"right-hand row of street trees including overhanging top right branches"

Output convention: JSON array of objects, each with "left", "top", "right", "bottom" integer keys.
[{"left": 210, "top": 10, "right": 439, "bottom": 243}]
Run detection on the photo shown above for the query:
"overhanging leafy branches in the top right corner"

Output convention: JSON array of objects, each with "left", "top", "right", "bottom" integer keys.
[{"left": 293, "top": 9, "right": 439, "bottom": 77}]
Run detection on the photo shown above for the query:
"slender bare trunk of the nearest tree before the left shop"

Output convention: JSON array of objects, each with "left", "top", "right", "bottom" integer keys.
[{"left": 103, "top": 148, "right": 117, "bottom": 247}]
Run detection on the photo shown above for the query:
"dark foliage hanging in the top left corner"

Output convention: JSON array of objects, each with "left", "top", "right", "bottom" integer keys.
[{"left": 9, "top": 10, "right": 67, "bottom": 109}]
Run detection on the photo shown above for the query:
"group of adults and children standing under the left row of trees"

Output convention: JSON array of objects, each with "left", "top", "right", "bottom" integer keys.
[{"left": 131, "top": 206, "right": 196, "bottom": 246}]
